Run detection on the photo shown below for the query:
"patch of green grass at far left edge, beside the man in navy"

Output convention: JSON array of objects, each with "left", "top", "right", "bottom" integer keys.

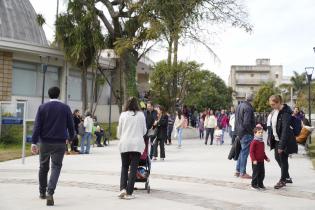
[{"left": 0, "top": 144, "right": 31, "bottom": 162}]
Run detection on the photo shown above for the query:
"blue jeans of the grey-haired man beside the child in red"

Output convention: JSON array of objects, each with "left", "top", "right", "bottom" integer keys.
[{"left": 236, "top": 135, "right": 253, "bottom": 175}]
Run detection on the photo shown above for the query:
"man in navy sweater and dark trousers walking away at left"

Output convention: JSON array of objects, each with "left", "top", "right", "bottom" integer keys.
[{"left": 32, "top": 87, "right": 74, "bottom": 206}]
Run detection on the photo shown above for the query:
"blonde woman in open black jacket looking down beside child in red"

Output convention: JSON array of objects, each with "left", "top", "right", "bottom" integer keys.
[{"left": 269, "top": 95, "right": 298, "bottom": 189}]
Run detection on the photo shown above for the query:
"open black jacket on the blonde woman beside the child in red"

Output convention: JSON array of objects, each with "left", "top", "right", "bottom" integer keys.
[{"left": 270, "top": 104, "right": 298, "bottom": 154}]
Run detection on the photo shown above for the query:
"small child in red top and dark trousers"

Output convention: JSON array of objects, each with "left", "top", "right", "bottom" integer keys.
[{"left": 249, "top": 124, "right": 270, "bottom": 190}]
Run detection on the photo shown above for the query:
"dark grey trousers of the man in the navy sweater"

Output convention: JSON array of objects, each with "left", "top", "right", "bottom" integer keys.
[{"left": 39, "top": 143, "right": 66, "bottom": 195}]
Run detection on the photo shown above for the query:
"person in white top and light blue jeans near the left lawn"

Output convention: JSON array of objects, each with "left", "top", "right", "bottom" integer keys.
[{"left": 80, "top": 111, "right": 94, "bottom": 154}]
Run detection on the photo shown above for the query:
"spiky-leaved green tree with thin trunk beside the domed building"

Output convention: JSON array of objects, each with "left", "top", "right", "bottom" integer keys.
[{"left": 56, "top": 0, "right": 105, "bottom": 111}]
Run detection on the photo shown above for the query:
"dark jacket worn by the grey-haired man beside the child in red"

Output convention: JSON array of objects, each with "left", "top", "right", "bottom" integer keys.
[{"left": 235, "top": 101, "right": 256, "bottom": 139}]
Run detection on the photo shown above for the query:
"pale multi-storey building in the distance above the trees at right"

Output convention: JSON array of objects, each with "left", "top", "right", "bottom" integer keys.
[{"left": 229, "top": 59, "right": 283, "bottom": 104}]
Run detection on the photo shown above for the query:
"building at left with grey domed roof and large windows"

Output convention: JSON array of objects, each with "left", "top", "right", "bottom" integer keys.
[{"left": 0, "top": 0, "right": 151, "bottom": 122}]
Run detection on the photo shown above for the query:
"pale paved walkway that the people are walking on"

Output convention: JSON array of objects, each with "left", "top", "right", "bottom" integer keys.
[{"left": 0, "top": 131, "right": 315, "bottom": 210}]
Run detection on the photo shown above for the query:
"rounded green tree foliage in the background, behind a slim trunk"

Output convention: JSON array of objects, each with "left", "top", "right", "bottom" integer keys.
[{"left": 150, "top": 61, "right": 232, "bottom": 110}]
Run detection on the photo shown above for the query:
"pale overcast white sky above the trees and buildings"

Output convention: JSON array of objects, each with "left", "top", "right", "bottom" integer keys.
[{"left": 30, "top": 0, "right": 315, "bottom": 82}]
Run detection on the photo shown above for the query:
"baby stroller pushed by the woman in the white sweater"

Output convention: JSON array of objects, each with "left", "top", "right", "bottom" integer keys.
[{"left": 135, "top": 140, "right": 151, "bottom": 193}]
